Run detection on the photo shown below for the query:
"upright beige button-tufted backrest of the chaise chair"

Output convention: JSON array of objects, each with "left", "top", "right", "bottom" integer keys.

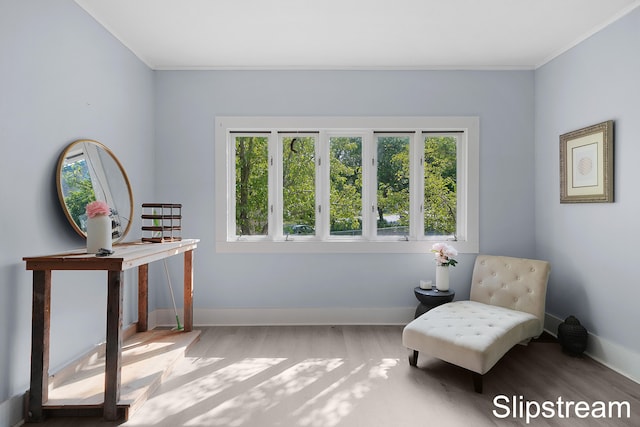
[{"left": 470, "top": 255, "right": 551, "bottom": 323}]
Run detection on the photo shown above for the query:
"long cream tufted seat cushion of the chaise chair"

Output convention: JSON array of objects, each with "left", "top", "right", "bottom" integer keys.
[{"left": 402, "top": 301, "right": 541, "bottom": 374}]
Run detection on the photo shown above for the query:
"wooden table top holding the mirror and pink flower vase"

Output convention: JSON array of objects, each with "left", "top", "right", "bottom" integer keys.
[{"left": 22, "top": 239, "right": 200, "bottom": 271}]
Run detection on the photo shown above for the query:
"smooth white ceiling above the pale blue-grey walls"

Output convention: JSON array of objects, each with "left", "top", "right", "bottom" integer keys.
[{"left": 76, "top": 0, "right": 640, "bottom": 70}]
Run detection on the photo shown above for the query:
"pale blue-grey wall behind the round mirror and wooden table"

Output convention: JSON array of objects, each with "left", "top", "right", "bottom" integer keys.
[{"left": 0, "top": 0, "right": 154, "bottom": 425}]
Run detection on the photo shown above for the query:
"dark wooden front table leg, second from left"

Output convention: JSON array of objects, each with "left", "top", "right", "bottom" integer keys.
[{"left": 104, "top": 271, "right": 123, "bottom": 421}]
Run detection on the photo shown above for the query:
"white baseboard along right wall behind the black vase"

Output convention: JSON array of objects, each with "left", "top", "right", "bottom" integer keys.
[{"left": 544, "top": 313, "right": 640, "bottom": 384}]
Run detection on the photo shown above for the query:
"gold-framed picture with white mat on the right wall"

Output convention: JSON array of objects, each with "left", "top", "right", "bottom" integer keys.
[{"left": 560, "top": 120, "right": 613, "bottom": 203}]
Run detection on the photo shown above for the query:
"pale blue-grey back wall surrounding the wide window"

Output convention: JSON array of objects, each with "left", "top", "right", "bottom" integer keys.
[{"left": 156, "top": 71, "right": 535, "bottom": 314}]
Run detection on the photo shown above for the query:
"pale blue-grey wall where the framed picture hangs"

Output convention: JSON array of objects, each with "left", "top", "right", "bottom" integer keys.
[{"left": 535, "top": 9, "right": 640, "bottom": 356}]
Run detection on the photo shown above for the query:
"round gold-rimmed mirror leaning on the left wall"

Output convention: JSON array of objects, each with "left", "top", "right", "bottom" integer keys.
[{"left": 56, "top": 139, "right": 133, "bottom": 243}]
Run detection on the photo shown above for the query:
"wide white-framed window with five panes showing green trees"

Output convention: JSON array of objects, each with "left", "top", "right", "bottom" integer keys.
[{"left": 215, "top": 117, "right": 479, "bottom": 253}]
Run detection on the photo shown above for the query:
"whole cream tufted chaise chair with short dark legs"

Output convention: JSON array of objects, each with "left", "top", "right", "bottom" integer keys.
[{"left": 402, "top": 255, "right": 550, "bottom": 393}]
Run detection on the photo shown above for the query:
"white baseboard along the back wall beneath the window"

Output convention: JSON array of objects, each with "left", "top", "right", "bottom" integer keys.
[{"left": 149, "top": 307, "right": 416, "bottom": 327}]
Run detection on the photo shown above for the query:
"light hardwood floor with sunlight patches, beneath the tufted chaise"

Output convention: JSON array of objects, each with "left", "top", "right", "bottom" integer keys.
[{"left": 36, "top": 326, "right": 640, "bottom": 427}]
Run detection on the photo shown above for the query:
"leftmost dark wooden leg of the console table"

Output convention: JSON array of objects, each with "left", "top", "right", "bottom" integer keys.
[{"left": 26, "top": 270, "right": 51, "bottom": 422}]
